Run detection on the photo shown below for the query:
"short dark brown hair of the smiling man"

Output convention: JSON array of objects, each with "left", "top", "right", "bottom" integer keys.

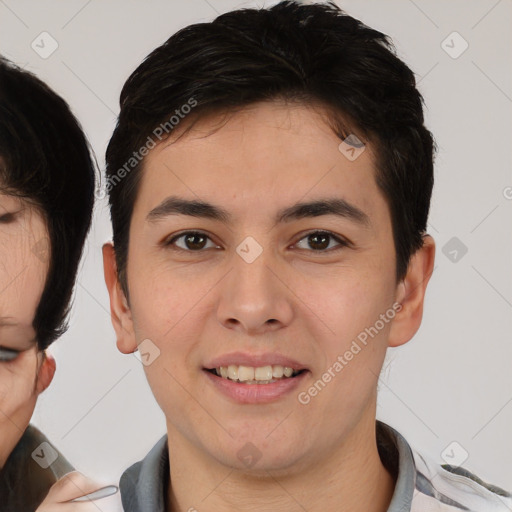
[{"left": 106, "top": 1, "right": 435, "bottom": 297}]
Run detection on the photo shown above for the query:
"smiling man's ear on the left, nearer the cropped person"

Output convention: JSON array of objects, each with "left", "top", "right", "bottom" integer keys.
[{"left": 103, "top": 242, "right": 137, "bottom": 354}]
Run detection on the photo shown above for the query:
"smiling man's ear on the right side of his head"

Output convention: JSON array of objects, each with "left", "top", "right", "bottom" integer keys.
[{"left": 388, "top": 235, "right": 436, "bottom": 347}]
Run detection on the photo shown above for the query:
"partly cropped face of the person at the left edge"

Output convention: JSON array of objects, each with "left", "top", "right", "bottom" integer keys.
[{"left": 0, "top": 193, "right": 53, "bottom": 468}]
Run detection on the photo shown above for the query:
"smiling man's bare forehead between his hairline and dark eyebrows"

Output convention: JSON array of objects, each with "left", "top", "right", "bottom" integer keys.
[{"left": 134, "top": 102, "right": 385, "bottom": 224}]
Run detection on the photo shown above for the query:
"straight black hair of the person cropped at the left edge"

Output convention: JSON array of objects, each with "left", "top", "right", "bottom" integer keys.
[{"left": 0, "top": 58, "right": 95, "bottom": 350}]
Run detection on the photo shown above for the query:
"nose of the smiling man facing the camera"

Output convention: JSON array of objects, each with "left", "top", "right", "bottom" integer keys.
[{"left": 217, "top": 250, "right": 293, "bottom": 334}]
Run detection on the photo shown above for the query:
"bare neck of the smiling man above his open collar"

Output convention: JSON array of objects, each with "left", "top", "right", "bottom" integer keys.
[{"left": 166, "top": 408, "right": 396, "bottom": 512}]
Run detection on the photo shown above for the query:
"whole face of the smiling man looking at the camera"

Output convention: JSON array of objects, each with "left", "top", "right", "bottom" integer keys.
[{"left": 106, "top": 103, "right": 422, "bottom": 470}]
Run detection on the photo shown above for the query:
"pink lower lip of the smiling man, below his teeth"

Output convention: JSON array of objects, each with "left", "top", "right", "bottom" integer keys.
[{"left": 203, "top": 370, "right": 308, "bottom": 404}]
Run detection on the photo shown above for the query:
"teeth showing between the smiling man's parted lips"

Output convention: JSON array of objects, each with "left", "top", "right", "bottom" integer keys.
[{"left": 205, "top": 365, "right": 307, "bottom": 384}]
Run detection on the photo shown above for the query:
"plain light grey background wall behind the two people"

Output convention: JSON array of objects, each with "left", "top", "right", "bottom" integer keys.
[{"left": 0, "top": 0, "right": 512, "bottom": 489}]
